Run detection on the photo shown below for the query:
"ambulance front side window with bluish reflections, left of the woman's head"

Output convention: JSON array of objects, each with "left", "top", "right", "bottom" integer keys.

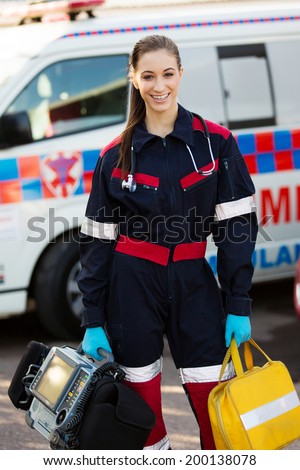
[{"left": 6, "top": 55, "right": 128, "bottom": 141}]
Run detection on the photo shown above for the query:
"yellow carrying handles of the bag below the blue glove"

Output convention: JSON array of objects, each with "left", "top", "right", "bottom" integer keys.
[{"left": 219, "top": 338, "right": 273, "bottom": 383}]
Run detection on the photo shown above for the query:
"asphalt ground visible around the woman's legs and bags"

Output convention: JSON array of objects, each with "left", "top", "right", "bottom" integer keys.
[{"left": 0, "top": 281, "right": 300, "bottom": 450}]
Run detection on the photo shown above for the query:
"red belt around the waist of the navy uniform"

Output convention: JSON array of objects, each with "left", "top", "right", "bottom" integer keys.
[{"left": 115, "top": 235, "right": 206, "bottom": 266}]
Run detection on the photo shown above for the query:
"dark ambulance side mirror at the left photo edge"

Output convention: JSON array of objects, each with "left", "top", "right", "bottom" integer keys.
[{"left": 0, "top": 111, "right": 33, "bottom": 148}]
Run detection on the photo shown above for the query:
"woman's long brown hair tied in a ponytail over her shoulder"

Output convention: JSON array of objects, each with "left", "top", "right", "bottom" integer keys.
[{"left": 118, "top": 34, "right": 181, "bottom": 176}]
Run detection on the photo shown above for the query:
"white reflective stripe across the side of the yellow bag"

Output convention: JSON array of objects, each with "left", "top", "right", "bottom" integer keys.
[{"left": 240, "top": 390, "right": 300, "bottom": 430}]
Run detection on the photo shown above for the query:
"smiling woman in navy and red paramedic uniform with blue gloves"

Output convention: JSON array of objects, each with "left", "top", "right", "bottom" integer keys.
[{"left": 78, "top": 35, "right": 257, "bottom": 449}]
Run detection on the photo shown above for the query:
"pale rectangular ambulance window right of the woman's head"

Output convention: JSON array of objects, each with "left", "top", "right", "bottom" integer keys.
[{"left": 218, "top": 44, "right": 275, "bottom": 129}]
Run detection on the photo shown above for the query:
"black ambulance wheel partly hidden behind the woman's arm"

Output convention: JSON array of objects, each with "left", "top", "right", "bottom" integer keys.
[{"left": 34, "top": 236, "right": 82, "bottom": 340}]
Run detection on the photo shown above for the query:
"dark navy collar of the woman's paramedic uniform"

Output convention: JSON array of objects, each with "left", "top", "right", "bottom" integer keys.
[{"left": 132, "top": 104, "right": 194, "bottom": 152}]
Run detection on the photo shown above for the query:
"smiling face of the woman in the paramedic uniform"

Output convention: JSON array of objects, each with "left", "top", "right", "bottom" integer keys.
[{"left": 132, "top": 49, "right": 183, "bottom": 114}]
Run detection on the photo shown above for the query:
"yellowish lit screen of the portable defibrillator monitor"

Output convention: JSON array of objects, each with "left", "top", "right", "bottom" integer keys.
[{"left": 35, "top": 355, "right": 74, "bottom": 408}]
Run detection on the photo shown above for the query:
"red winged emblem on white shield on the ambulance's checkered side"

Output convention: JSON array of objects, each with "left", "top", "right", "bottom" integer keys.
[{"left": 42, "top": 152, "right": 82, "bottom": 197}]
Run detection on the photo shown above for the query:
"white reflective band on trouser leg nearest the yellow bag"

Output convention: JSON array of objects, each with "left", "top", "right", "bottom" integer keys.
[{"left": 179, "top": 361, "right": 235, "bottom": 384}]
